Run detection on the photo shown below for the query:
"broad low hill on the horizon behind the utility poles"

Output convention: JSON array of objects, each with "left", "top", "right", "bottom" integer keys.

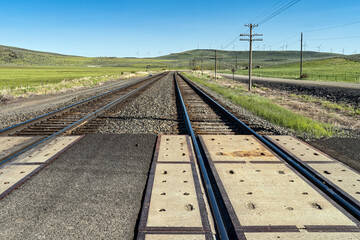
[{"left": 156, "top": 49, "right": 342, "bottom": 68}]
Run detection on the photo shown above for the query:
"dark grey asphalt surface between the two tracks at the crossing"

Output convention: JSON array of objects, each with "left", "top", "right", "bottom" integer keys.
[{"left": 0, "top": 134, "right": 156, "bottom": 239}]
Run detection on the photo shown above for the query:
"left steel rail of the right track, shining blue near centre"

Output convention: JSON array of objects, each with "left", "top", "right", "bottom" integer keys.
[{"left": 174, "top": 73, "right": 229, "bottom": 240}]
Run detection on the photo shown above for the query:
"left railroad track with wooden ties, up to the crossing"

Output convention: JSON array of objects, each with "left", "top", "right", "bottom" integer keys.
[{"left": 0, "top": 73, "right": 166, "bottom": 165}]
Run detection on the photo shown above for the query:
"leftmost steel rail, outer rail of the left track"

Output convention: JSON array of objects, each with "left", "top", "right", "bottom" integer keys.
[{"left": 0, "top": 74, "right": 161, "bottom": 134}]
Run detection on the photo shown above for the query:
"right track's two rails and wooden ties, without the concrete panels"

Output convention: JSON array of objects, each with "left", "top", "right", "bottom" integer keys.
[{"left": 174, "top": 74, "right": 360, "bottom": 239}]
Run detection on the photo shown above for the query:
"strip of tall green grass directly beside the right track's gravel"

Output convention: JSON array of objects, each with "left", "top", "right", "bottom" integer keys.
[{"left": 185, "top": 74, "right": 335, "bottom": 138}]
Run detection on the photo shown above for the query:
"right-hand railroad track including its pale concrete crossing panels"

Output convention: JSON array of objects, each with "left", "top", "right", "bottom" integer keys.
[{"left": 138, "top": 73, "right": 360, "bottom": 239}]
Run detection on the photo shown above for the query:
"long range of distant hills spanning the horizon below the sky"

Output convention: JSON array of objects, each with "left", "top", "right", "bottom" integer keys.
[{"left": 0, "top": 45, "right": 342, "bottom": 69}]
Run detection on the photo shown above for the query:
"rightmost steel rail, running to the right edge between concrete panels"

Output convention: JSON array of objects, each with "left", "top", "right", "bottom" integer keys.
[{"left": 179, "top": 73, "right": 360, "bottom": 220}]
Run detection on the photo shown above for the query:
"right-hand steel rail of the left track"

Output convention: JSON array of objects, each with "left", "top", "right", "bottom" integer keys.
[{"left": 0, "top": 76, "right": 161, "bottom": 166}]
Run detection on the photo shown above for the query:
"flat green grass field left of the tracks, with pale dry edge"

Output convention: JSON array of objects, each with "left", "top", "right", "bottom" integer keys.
[{"left": 0, "top": 66, "right": 149, "bottom": 96}]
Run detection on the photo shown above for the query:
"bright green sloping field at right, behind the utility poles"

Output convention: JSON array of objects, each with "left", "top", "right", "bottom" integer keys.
[{"left": 227, "top": 58, "right": 360, "bottom": 83}]
